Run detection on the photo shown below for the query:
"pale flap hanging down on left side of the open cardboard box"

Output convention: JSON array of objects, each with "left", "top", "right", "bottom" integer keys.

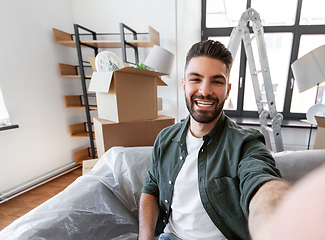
[{"left": 88, "top": 72, "right": 114, "bottom": 93}]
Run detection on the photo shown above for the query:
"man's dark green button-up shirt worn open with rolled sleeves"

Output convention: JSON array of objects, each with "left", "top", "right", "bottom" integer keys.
[{"left": 142, "top": 113, "right": 280, "bottom": 239}]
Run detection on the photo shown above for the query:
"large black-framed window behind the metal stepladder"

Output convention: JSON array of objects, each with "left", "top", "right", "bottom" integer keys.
[{"left": 202, "top": 0, "right": 325, "bottom": 120}]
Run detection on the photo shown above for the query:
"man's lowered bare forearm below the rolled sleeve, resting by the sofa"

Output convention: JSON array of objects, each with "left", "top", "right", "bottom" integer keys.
[{"left": 138, "top": 193, "right": 159, "bottom": 240}]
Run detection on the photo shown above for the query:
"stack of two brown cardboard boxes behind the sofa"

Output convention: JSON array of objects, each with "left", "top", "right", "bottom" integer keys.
[{"left": 89, "top": 67, "right": 175, "bottom": 158}]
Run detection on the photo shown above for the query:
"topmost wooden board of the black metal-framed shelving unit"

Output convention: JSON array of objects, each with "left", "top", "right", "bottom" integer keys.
[{"left": 53, "top": 26, "right": 160, "bottom": 48}]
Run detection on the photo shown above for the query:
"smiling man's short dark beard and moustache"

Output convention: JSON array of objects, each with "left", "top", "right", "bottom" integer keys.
[{"left": 185, "top": 94, "right": 226, "bottom": 123}]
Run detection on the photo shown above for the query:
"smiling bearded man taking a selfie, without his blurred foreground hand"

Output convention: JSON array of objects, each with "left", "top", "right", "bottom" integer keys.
[{"left": 139, "top": 40, "right": 288, "bottom": 240}]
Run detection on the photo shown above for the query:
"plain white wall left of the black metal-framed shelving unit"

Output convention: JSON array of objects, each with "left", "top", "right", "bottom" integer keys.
[{"left": 0, "top": 0, "right": 89, "bottom": 193}]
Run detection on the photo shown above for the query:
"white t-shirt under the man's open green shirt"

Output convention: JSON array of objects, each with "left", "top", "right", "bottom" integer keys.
[{"left": 164, "top": 130, "right": 226, "bottom": 240}]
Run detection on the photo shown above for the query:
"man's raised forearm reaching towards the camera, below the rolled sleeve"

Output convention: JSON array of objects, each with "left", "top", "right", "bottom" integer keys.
[{"left": 248, "top": 180, "right": 290, "bottom": 240}]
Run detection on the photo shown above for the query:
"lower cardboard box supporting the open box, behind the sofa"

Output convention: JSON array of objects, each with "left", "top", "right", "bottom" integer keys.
[{"left": 94, "top": 115, "right": 175, "bottom": 158}]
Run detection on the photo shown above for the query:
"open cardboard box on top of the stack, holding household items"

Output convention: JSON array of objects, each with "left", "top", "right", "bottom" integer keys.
[{"left": 88, "top": 67, "right": 167, "bottom": 123}]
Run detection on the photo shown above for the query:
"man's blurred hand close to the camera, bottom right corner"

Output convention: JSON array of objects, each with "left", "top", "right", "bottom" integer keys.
[{"left": 273, "top": 164, "right": 325, "bottom": 240}]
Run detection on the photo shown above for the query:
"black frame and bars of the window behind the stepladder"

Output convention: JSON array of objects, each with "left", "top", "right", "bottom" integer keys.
[{"left": 201, "top": 0, "right": 325, "bottom": 120}]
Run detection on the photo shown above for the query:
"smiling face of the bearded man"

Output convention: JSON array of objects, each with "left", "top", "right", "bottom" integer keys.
[{"left": 182, "top": 56, "right": 231, "bottom": 123}]
